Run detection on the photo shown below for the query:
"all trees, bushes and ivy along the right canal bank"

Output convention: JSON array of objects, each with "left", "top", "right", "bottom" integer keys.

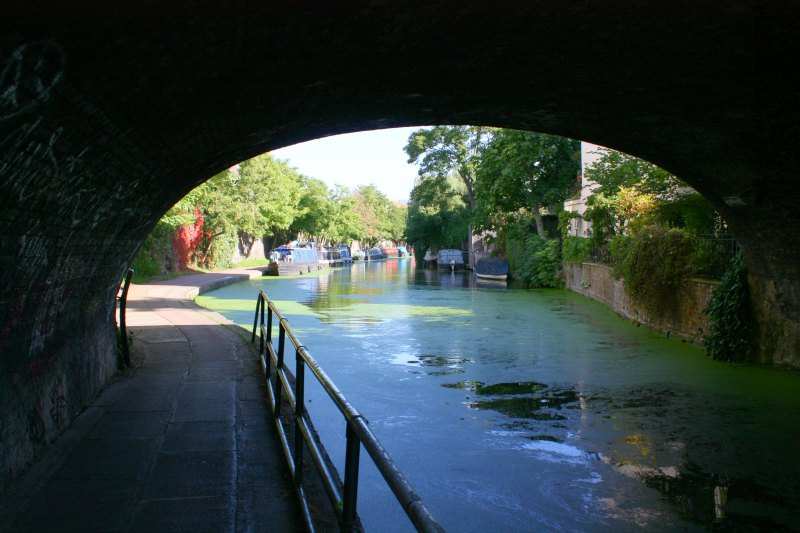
[{"left": 405, "top": 126, "right": 750, "bottom": 360}]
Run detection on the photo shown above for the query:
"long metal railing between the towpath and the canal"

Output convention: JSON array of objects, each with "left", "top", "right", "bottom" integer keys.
[{"left": 251, "top": 291, "right": 444, "bottom": 532}]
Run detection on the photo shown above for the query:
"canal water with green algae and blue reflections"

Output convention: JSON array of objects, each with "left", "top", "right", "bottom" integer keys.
[{"left": 198, "top": 260, "right": 800, "bottom": 532}]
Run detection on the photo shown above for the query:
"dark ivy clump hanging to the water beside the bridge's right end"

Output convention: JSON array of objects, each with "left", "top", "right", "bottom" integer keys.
[{"left": 704, "top": 254, "right": 754, "bottom": 361}]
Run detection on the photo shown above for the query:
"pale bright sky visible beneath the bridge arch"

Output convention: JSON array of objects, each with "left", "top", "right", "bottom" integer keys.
[{"left": 272, "top": 128, "right": 419, "bottom": 202}]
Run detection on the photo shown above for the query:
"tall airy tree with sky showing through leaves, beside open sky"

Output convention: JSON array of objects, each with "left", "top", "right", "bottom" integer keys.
[{"left": 405, "top": 126, "right": 494, "bottom": 264}]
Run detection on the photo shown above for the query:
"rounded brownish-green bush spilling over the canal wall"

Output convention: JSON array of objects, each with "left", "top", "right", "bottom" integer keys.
[{"left": 612, "top": 226, "right": 695, "bottom": 315}]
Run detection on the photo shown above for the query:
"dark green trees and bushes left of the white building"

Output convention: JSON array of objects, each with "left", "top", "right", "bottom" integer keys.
[{"left": 405, "top": 126, "right": 580, "bottom": 274}]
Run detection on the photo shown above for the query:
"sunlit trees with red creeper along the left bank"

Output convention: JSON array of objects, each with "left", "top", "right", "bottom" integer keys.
[{"left": 133, "top": 154, "right": 407, "bottom": 282}]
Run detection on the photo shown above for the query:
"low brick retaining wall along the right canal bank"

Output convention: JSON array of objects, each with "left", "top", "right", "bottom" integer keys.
[{"left": 564, "top": 263, "right": 719, "bottom": 343}]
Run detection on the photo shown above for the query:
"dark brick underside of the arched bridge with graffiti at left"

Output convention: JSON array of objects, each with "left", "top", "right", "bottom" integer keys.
[{"left": 0, "top": 0, "right": 800, "bottom": 494}]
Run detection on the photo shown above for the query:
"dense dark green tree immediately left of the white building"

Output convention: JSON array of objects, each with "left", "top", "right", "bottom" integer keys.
[{"left": 476, "top": 129, "right": 580, "bottom": 238}]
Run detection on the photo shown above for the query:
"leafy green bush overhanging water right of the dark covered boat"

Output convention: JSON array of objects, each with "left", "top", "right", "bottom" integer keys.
[{"left": 505, "top": 220, "right": 563, "bottom": 288}]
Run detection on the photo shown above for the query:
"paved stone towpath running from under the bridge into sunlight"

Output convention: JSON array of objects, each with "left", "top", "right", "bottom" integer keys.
[{"left": 5, "top": 270, "right": 302, "bottom": 533}]
